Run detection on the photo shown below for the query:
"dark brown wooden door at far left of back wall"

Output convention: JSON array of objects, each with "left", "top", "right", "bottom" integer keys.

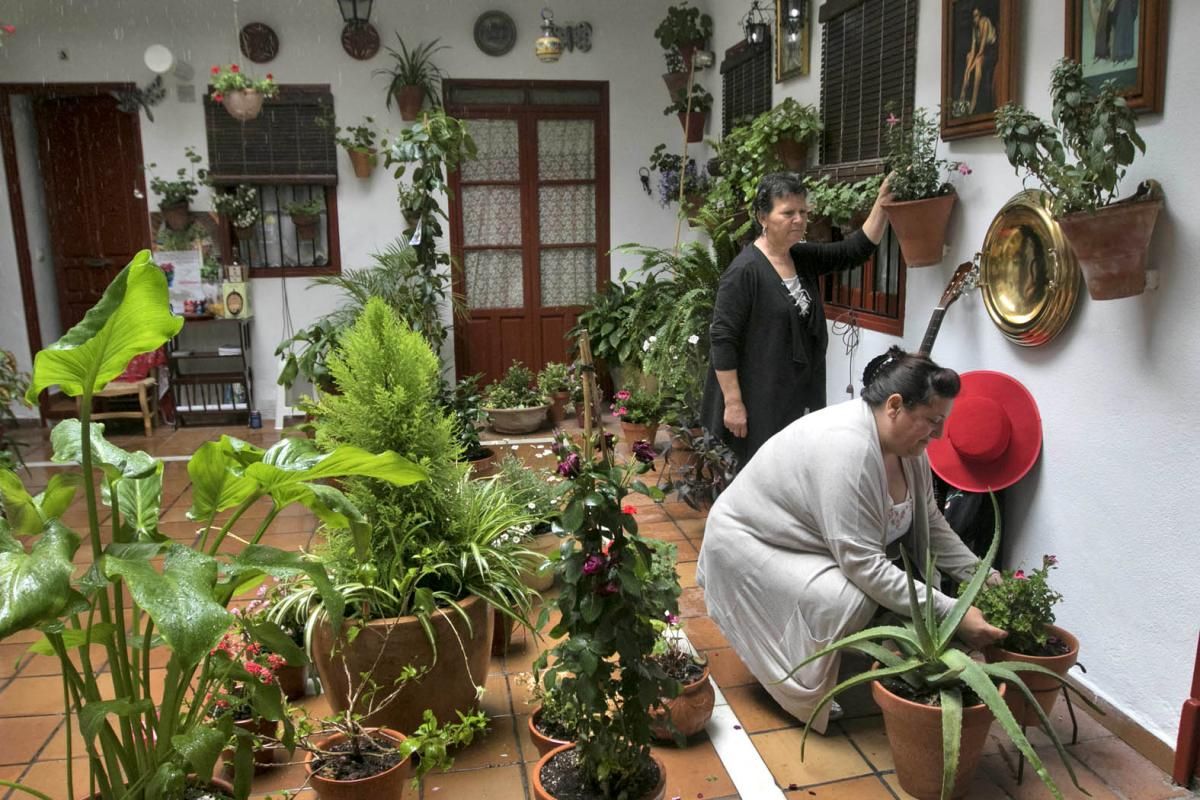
[{"left": 34, "top": 94, "right": 150, "bottom": 330}]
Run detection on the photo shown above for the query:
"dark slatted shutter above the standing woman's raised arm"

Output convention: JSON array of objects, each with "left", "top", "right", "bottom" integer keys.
[{"left": 820, "top": 0, "right": 919, "bottom": 164}]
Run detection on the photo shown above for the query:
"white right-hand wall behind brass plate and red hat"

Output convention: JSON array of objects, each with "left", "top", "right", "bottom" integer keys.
[{"left": 708, "top": 0, "right": 1200, "bottom": 746}]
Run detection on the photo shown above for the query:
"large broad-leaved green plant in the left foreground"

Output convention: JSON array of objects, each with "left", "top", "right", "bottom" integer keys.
[{"left": 0, "top": 251, "right": 425, "bottom": 800}]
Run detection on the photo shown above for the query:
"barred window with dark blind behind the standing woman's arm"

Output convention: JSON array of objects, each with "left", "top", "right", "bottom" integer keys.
[{"left": 818, "top": 0, "right": 919, "bottom": 336}]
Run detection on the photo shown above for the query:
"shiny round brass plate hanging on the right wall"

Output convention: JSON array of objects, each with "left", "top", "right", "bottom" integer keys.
[{"left": 979, "top": 190, "right": 1081, "bottom": 347}]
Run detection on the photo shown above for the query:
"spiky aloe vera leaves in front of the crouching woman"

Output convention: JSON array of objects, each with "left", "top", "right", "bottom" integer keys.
[{"left": 785, "top": 494, "right": 1096, "bottom": 800}]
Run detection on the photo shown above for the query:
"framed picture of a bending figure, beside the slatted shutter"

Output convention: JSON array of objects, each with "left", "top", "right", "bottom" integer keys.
[{"left": 942, "top": 0, "right": 1020, "bottom": 139}]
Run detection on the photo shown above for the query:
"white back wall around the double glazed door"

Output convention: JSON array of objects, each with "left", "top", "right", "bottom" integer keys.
[{"left": 0, "top": 0, "right": 688, "bottom": 416}]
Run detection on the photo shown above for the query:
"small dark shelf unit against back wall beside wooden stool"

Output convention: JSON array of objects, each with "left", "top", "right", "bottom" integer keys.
[{"left": 167, "top": 317, "right": 254, "bottom": 428}]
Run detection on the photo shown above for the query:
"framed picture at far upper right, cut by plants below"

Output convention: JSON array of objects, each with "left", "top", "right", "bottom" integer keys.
[{"left": 1066, "top": 0, "right": 1166, "bottom": 114}]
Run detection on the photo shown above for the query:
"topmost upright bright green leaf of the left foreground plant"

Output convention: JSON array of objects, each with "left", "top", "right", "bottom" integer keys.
[{"left": 25, "top": 249, "right": 184, "bottom": 402}]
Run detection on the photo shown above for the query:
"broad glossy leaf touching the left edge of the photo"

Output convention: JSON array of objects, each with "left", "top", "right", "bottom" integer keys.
[{"left": 0, "top": 519, "right": 79, "bottom": 639}]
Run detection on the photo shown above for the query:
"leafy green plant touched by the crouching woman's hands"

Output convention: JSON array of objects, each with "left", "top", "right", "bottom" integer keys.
[{"left": 976, "top": 555, "right": 1062, "bottom": 656}]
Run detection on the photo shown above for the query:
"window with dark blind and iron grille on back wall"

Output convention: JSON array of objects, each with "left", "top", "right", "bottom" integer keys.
[{"left": 204, "top": 85, "right": 341, "bottom": 277}]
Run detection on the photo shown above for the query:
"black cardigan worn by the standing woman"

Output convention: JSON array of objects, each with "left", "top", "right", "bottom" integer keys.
[{"left": 702, "top": 230, "right": 876, "bottom": 465}]
